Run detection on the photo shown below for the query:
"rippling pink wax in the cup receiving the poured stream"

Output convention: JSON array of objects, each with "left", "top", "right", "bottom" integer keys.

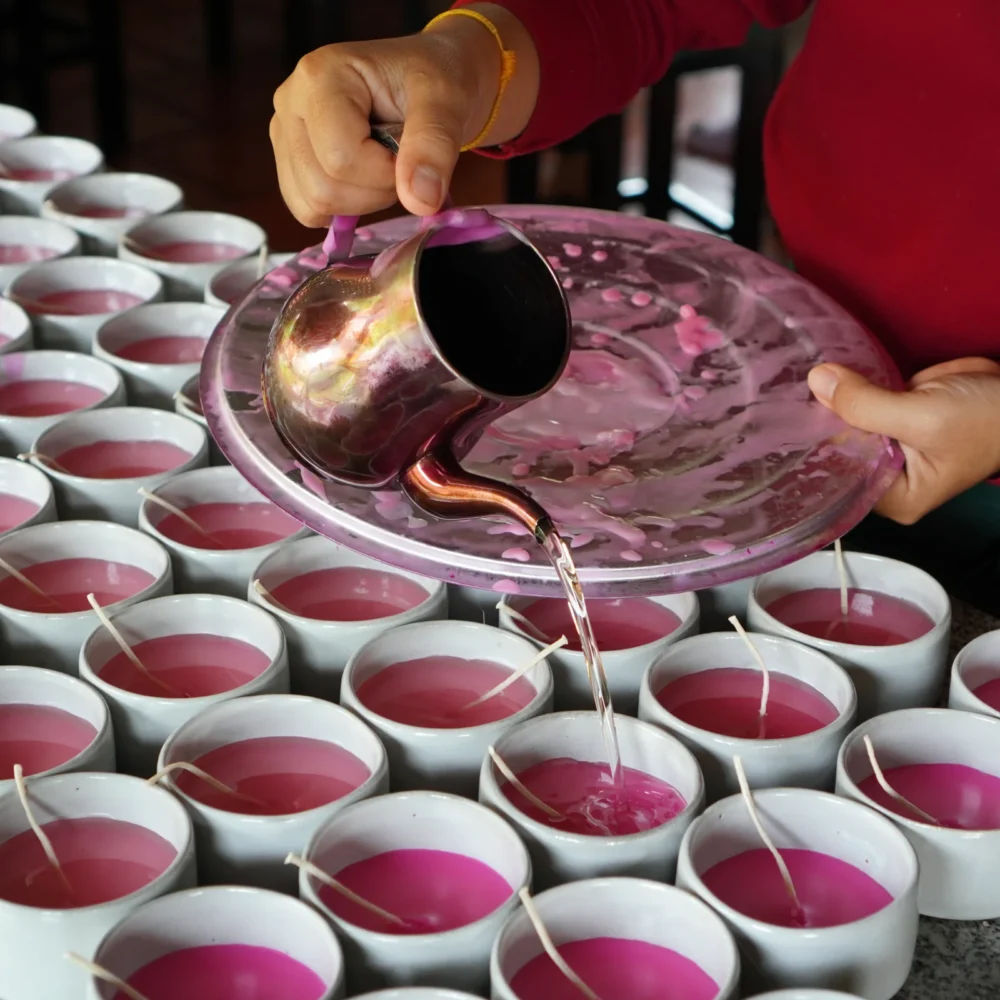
[{"left": 501, "top": 757, "right": 687, "bottom": 837}]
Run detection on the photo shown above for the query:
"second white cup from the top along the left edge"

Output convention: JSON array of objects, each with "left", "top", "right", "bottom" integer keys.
[{"left": 0, "top": 135, "right": 104, "bottom": 215}]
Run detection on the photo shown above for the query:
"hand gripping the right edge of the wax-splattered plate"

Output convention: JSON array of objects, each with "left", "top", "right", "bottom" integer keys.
[{"left": 809, "top": 358, "right": 1000, "bottom": 524}]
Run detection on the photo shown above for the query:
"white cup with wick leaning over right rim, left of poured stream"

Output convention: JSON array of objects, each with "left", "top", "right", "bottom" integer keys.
[{"left": 340, "top": 621, "right": 552, "bottom": 797}]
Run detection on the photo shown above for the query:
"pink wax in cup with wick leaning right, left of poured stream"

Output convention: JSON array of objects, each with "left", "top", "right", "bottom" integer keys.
[{"left": 357, "top": 656, "right": 537, "bottom": 729}]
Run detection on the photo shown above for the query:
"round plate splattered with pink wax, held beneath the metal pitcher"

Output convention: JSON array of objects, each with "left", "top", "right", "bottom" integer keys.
[{"left": 201, "top": 205, "right": 901, "bottom": 598}]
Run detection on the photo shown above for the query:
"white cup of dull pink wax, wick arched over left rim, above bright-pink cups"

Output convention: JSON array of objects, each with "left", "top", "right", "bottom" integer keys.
[{"left": 156, "top": 694, "right": 389, "bottom": 893}]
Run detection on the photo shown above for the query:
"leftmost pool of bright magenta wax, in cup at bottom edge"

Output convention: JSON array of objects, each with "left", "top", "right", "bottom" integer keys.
[{"left": 123, "top": 944, "right": 326, "bottom": 1000}]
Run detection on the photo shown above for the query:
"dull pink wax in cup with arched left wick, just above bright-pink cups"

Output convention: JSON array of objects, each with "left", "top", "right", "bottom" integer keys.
[{"left": 176, "top": 736, "right": 371, "bottom": 816}]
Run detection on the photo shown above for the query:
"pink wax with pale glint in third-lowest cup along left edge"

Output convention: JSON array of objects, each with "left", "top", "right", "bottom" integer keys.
[{"left": 0, "top": 559, "right": 156, "bottom": 615}]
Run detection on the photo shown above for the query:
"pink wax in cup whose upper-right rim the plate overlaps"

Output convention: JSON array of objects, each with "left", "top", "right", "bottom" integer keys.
[{"left": 156, "top": 501, "right": 302, "bottom": 549}]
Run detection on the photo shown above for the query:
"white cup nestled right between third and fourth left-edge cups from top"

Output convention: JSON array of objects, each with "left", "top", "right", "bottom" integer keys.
[{"left": 7, "top": 257, "right": 163, "bottom": 354}]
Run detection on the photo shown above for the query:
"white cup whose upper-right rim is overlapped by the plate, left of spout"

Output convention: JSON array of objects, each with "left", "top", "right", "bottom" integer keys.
[{"left": 139, "top": 465, "right": 309, "bottom": 596}]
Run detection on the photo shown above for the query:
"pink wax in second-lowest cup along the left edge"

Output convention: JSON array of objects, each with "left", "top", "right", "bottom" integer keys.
[{"left": 0, "top": 704, "right": 97, "bottom": 779}]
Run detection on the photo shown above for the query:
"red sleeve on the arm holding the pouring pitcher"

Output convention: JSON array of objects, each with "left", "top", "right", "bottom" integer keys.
[{"left": 453, "top": 0, "right": 810, "bottom": 156}]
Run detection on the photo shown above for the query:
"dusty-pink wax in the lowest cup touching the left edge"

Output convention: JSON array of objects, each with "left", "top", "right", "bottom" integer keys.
[{"left": 0, "top": 816, "right": 177, "bottom": 910}]
